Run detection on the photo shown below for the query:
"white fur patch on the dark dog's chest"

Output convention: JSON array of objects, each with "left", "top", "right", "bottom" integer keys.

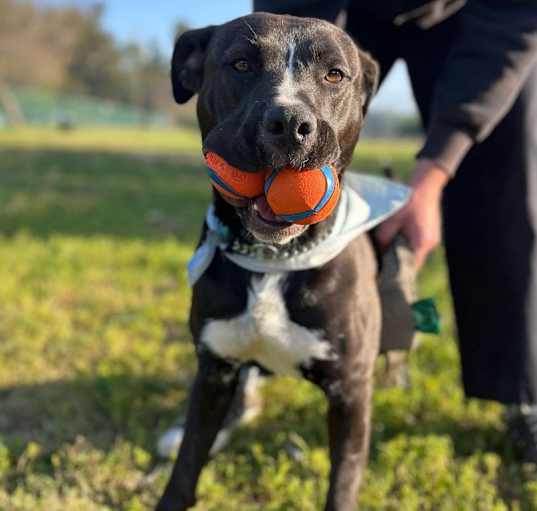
[{"left": 201, "top": 273, "right": 334, "bottom": 375}]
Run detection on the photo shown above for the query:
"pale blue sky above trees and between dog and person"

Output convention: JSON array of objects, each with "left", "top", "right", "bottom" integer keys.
[{"left": 34, "top": 0, "right": 415, "bottom": 114}]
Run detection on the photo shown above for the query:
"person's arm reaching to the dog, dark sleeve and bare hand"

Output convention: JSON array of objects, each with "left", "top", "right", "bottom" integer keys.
[{"left": 376, "top": 0, "right": 537, "bottom": 268}]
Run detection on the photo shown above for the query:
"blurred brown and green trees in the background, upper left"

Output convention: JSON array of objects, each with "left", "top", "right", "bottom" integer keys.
[{"left": 0, "top": 0, "right": 178, "bottom": 119}]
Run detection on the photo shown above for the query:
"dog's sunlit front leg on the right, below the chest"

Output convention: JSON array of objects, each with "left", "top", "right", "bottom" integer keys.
[{"left": 325, "top": 378, "right": 372, "bottom": 511}]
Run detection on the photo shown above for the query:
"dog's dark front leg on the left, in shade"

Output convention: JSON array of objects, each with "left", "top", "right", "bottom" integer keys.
[{"left": 156, "top": 352, "right": 238, "bottom": 511}]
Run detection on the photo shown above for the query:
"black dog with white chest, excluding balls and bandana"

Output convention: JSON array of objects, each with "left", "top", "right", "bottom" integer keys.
[{"left": 158, "top": 13, "right": 381, "bottom": 511}]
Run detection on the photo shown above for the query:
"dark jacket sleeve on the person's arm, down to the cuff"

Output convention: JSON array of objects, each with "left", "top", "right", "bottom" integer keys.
[{"left": 418, "top": 0, "right": 537, "bottom": 174}]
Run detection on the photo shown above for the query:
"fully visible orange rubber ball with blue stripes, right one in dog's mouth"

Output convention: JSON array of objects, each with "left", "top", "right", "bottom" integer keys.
[{"left": 265, "top": 165, "right": 339, "bottom": 224}]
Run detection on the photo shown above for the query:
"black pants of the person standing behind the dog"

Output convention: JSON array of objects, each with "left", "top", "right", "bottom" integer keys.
[{"left": 254, "top": 0, "right": 537, "bottom": 403}]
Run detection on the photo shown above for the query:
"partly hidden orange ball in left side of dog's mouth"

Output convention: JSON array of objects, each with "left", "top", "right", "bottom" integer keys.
[{"left": 205, "top": 152, "right": 265, "bottom": 199}]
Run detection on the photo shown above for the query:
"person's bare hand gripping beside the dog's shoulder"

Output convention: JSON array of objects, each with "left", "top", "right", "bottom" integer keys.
[{"left": 375, "top": 159, "right": 449, "bottom": 269}]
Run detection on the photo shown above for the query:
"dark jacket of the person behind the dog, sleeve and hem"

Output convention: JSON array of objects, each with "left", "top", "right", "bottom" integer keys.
[{"left": 254, "top": 0, "right": 537, "bottom": 174}]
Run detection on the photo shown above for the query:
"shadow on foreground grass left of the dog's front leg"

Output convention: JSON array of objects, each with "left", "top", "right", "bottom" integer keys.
[{"left": 0, "top": 374, "right": 193, "bottom": 456}]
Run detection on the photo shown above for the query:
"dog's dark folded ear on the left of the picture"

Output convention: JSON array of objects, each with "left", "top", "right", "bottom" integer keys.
[{"left": 171, "top": 25, "right": 217, "bottom": 103}]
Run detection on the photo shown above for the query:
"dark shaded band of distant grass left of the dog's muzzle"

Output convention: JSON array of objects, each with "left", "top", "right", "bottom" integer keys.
[{"left": 0, "top": 149, "right": 210, "bottom": 242}]
